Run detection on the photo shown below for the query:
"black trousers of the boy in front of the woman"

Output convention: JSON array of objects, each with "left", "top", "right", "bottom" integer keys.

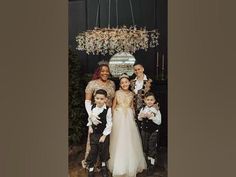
[{"left": 86, "top": 133, "right": 110, "bottom": 168}]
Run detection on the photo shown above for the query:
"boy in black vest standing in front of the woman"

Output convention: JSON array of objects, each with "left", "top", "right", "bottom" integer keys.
[{"left": 86, "top": 89, "right": 112, "bottom": 177}]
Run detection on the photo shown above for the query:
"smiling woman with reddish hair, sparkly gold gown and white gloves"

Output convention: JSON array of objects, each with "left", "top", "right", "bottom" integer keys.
[{"left": 82, "top": 62, "right": 115, "bottom": 167}]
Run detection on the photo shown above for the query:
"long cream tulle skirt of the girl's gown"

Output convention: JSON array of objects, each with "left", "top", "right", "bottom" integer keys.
[{"left": 108, "top": 108, "right": 147, "bottom": 177}]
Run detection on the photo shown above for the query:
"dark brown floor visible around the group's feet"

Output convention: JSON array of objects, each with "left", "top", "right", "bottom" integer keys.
[{"left": 69, "top": 145, "right": 167, "bottom": 177}]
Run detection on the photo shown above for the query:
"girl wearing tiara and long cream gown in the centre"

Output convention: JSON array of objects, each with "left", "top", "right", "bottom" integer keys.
[{"left": 108, "top": 74, "right": 147, "bottom": 177}]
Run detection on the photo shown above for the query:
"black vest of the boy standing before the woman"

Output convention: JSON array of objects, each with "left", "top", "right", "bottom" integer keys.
[{"left": 91, "top": 105, "right": 108, "bottom": 134}]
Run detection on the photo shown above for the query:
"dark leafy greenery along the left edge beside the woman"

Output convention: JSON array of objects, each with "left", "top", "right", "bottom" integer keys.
[{"left": 69, "top": 49, "right": 91, "bottom": 146}]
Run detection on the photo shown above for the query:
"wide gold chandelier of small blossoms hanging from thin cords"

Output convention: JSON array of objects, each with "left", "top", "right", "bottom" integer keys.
[{"left": 76, "top": 0, "right": 159, "bottom": 55}]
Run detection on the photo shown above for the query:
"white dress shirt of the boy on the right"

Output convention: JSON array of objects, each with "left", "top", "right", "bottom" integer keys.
[{"left": 138, "top": 106, "right": 161, "bottom": 125}]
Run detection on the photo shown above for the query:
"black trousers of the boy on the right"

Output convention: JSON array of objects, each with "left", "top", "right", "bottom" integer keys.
[{"left": 141, "top": 130, "right": 159, "bottom": 158}]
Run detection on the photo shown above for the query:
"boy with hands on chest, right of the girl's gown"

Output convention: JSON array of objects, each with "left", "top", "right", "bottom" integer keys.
[{"left": 138, "top": 92, "right": 161, "bottom": 175}]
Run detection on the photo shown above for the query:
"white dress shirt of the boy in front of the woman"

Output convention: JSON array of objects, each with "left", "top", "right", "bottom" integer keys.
[{"left": 87, "top": 104, "right": 112, "bottom": 135}]
